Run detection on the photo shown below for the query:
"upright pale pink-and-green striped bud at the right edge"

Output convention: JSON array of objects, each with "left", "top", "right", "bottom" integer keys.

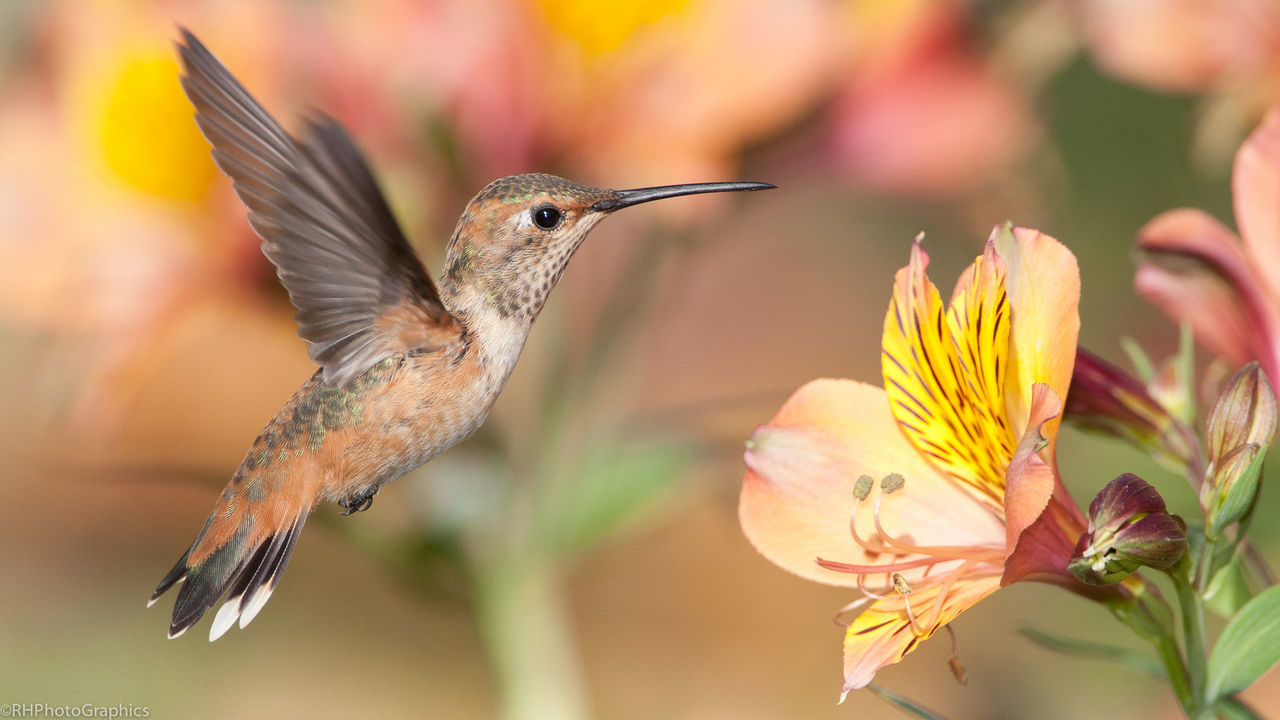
[{"left": 1201, "top": 363, "right": 1277, "bottom": 538}]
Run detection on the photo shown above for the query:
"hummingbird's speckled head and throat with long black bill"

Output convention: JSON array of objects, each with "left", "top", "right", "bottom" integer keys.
[{"left": 444, "top": 173, "right": 773, "bottom": 320}]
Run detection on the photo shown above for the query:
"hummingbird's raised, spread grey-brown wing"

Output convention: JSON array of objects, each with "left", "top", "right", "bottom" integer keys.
[{"left": 178, "top": 29, "right": 458, "bottom": 384}]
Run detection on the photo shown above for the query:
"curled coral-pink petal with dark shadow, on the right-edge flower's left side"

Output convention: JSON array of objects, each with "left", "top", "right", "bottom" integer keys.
[{"left": 1134, "top": 209, "right": 1277, "bottom": 373}]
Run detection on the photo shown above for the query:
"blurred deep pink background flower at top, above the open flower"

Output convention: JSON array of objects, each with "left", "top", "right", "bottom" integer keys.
[{"left": 832, "top": 0, "right": 1037, "bottom": 196}]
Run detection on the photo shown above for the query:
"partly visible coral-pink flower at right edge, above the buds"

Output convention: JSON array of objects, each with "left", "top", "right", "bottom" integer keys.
[{"left": 1134, "top": 108, "right": 1280, "bottom": 386}]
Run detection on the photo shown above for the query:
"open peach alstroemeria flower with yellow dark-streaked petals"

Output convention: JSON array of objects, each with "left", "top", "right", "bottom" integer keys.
[{"left": 740, "top": 228, "right": 1085, "bottom": 698}]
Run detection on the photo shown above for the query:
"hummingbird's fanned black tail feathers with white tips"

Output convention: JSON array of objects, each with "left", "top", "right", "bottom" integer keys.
[{"left": 147, "top": 511, "right": 308, "bottom": 642}]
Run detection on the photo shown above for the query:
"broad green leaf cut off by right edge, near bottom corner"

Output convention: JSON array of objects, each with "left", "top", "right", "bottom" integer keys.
[{"left": 1208, "top": 585, "right": 1280, "bottom": 698}]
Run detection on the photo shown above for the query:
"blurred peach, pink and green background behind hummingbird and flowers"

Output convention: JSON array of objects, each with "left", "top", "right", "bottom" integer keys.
[{"left": 0, "top": 0, "right": 1280, "bottom": 719}]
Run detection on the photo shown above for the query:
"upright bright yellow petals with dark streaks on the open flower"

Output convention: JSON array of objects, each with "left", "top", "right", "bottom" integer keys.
[{"left": 881, "top": 238, "right": 1014, "bottom": 507}]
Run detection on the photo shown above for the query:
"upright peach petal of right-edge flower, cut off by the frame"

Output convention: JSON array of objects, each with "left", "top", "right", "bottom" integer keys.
[{"left": 1231, "top": 109, "right": 1280, "bottom": 297}]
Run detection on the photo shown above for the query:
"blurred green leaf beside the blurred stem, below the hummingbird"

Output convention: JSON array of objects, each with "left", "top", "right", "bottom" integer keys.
[{"left": 550, "top": 442, "right": 694, "bottom": 552}]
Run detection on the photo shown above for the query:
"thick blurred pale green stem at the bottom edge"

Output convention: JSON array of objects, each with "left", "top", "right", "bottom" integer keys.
[{"left": 476, "top": 557, "right": 589, "bottom": 720}]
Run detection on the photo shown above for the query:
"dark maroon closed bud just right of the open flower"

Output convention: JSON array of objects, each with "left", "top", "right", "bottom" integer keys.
[{"left": 1068, "top": 473, "right": 1187, "bottom": 585}]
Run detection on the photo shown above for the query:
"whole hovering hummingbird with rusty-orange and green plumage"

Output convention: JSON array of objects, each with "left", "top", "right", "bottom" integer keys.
[{"left": 147, "top": 29, "right": 774, "bottom": 641}]
